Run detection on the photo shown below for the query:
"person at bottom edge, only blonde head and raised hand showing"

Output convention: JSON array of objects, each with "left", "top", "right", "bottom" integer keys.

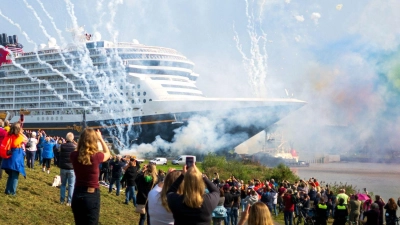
[{"left": 239, "top": 202, "right": 274, "bottom": 225}]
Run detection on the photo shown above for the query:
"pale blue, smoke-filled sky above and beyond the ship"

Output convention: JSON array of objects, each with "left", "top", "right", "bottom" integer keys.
[{"left": 0, "top": 0, "right": 400, "bottom": 158}]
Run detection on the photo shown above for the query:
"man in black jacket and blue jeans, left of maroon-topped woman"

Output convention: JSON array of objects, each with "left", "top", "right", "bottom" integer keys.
[{"left": 58, "top": 132, "right": 76, "bottom": 206}]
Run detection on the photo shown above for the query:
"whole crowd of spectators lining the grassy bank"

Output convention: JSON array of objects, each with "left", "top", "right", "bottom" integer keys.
[{"left": 0, "top": 120, "right": 400, "bottom": 225}]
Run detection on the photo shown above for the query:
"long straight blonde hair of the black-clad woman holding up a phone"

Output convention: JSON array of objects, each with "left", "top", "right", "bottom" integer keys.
[{"left": 183, "top": 167, "right": 206, "bottom": 208}]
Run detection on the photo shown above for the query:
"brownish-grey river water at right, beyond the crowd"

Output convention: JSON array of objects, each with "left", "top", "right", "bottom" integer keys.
[{"left": 292, "top": 162, "right": 400, "bottom": 202}]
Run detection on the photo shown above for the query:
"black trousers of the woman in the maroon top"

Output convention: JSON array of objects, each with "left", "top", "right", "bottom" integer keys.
[{"left": 71, "top": 187, "right": 100, "bottom": 225}]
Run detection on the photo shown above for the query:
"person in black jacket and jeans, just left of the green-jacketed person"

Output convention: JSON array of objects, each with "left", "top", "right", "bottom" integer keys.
[{"left": 121, "top": 158, "right": 138, "bottom": 207}]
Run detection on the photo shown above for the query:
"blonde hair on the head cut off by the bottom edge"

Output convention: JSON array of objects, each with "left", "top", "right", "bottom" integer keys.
[{"left": 247, "top": 202, "right": 274, "bottom": 225}]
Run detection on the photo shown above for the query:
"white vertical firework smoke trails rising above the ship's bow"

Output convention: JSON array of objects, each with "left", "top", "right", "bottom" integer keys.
[{"left": 233, "top": 0, "right": 268, "bottom": 97}]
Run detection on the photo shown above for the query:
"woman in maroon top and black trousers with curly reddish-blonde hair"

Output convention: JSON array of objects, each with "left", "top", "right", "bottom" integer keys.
[{"left": 70, "top": 128, "right": 110, "bottom": 225}]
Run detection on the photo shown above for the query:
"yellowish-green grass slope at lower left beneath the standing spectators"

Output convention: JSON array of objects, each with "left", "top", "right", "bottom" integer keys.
[{"left": 0, "top": 166, "right": 139, "bottom": 225}]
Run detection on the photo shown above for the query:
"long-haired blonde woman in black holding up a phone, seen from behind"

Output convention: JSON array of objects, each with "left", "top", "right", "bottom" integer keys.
[{"left": 167, "top": 165, "right": 220, "bottom": 225}]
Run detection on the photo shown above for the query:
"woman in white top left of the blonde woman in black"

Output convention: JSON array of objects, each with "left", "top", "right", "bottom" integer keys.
[{"left": 148, "top": 171, "right": 183, "bottom": 225}]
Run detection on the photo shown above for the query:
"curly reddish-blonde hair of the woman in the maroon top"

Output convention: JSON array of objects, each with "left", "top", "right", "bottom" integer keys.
[{"left": 77, "top": 128, "right": 99, "bottom": 165}]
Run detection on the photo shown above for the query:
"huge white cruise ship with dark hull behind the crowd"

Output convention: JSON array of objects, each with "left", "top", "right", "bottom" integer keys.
[{"left": 0, "top": 33, "right": 305, "bottom": 148}]
